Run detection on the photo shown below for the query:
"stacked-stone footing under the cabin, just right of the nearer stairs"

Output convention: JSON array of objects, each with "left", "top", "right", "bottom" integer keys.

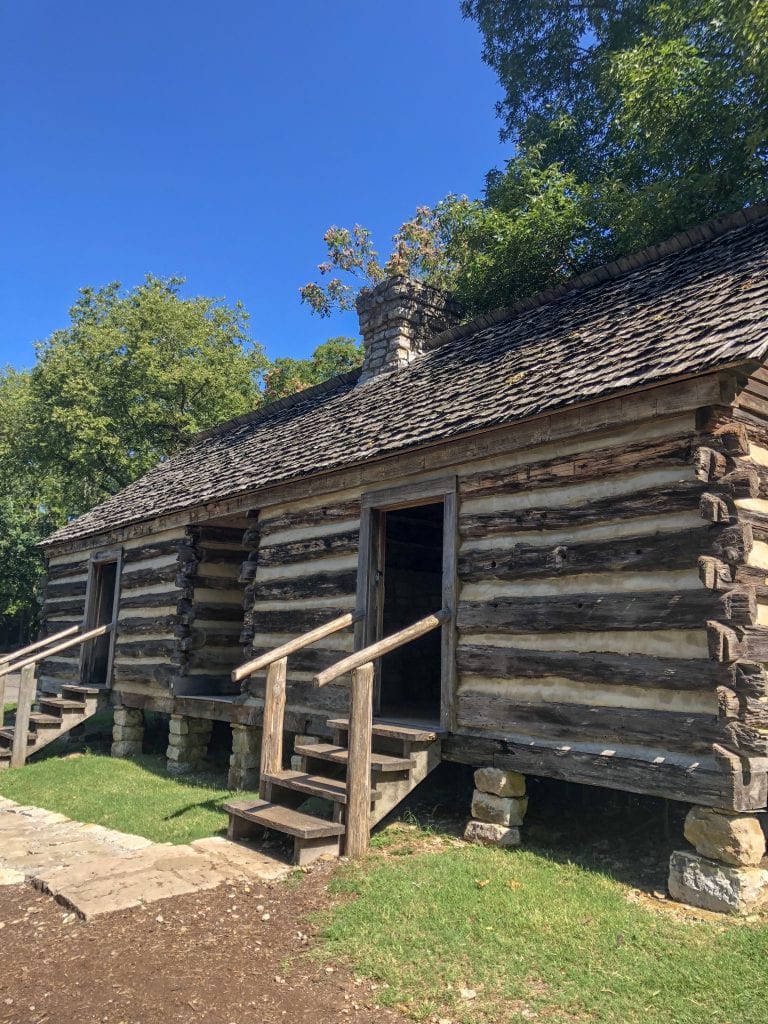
[{"left": 464, "top": 768, "right": 528, "bottom": 847}]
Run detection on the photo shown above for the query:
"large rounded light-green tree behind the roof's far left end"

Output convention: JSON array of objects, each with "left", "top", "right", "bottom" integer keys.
[{"left": 22, "top": 276, "right": 267, "bottom": 519}]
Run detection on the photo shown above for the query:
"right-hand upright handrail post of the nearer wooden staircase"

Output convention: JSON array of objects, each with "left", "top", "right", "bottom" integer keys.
[{"left": 344, "top": 662, "right": 374, "bottom": 858}]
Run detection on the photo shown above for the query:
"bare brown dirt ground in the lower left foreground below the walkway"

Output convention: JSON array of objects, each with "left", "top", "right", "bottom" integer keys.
[{"left": 0, "top": 865, "right": 402, "bottom": 1024}]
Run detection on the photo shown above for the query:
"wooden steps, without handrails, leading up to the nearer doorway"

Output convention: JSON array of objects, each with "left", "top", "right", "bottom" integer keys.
[{"left": 224, "top": 719, "right": 440, "bottom": 865}]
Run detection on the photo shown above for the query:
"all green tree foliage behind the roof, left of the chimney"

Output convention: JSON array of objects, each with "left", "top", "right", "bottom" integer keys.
[{"left": 0, "top": 275, "right": 359, "bottom": 627}]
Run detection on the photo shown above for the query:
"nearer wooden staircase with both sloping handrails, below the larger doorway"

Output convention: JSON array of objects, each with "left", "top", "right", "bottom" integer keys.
[{"left": 224, "top": 608, "right": 451, "bottom": 864}]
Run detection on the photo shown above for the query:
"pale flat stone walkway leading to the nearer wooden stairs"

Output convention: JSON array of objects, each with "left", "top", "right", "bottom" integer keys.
[{"left": 0, "top": 798, "right": 292, "bottom": 920}]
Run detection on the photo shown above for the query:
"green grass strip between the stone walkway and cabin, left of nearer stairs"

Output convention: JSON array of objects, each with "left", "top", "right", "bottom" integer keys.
[{"left": 0, "top": 744, "right": 260, "bottom": 843}]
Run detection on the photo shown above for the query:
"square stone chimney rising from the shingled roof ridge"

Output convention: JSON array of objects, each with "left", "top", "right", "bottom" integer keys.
[{"left": 356, "top": 278, "right": 461, "bottom": 381}]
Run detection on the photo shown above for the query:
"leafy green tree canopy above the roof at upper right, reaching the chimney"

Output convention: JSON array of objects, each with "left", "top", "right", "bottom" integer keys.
[{"left": 301, "top": 0, "right": 768, "bottom": 315}]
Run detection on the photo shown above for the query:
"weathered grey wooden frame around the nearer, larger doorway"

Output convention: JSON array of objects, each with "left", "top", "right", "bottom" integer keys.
[{"left": 354, "top": 476, "right": 459, "bottom": 731}]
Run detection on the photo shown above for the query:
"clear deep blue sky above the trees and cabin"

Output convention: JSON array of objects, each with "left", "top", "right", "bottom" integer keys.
[{"left": 0, "top": 0, "right": 508, "bottom": 368}]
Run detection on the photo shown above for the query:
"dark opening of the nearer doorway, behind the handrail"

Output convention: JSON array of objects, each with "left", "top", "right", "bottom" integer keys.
[{"left": 379, "top": 501, "right": 444, "bottom": 722}]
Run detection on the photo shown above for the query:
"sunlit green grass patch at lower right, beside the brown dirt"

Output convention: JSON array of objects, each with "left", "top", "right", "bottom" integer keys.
[{"left": 321, "top": 843, "right": 768, "bottom": 1024}]
